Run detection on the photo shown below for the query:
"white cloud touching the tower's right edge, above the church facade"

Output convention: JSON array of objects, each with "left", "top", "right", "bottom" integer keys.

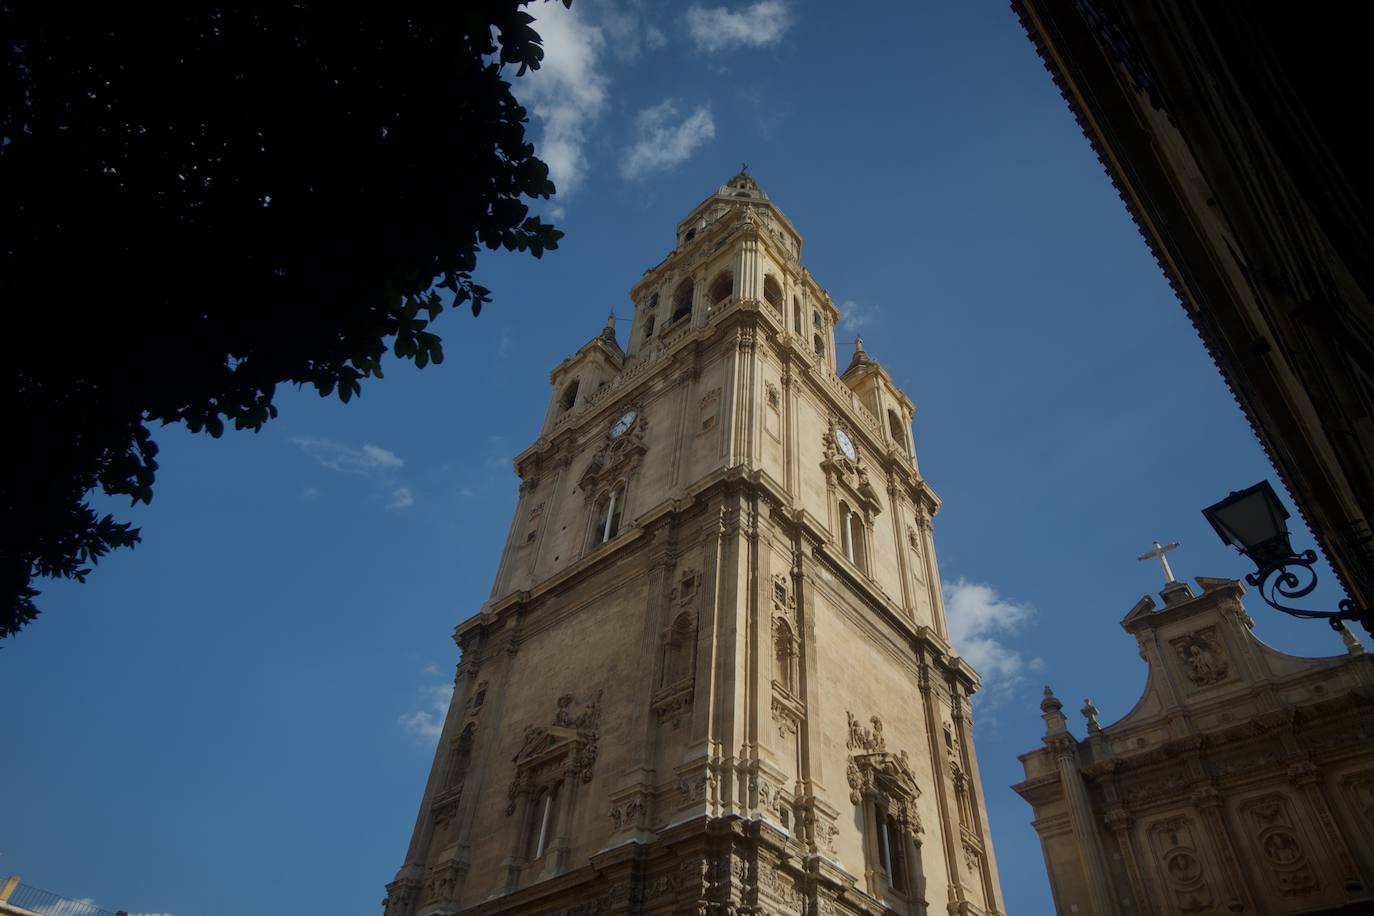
[{"left": 944, "top": 578, "right": 1040, "bottom": 702}]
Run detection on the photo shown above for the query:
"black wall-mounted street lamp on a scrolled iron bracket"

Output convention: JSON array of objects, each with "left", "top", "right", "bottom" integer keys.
[{"left": 1202, "top": 481, "right": 1374, "bottom": 636}]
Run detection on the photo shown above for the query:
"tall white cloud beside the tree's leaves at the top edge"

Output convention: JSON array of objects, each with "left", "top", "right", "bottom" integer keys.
[{"left": 514, "top": 4, "right": 607, "bottom": 198}]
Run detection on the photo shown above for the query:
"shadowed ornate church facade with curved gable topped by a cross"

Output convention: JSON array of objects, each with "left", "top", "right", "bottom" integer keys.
[{"left": 1014, "top": 578, "right": 1374, "bottom": 916}]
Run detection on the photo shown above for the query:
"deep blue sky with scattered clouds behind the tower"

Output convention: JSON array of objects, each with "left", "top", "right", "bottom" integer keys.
[{"left": 0, "top": 0, "right": 1357, "bottom": 916}]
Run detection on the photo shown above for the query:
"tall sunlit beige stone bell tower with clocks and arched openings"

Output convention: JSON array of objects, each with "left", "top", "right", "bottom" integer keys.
[{"left": 385, "top": 173, "right": 1003, "bottom": 916}]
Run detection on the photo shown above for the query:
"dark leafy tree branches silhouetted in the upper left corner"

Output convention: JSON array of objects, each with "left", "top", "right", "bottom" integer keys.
[{"left": 0, "top": 0, "right": 572, "bottom": 639}]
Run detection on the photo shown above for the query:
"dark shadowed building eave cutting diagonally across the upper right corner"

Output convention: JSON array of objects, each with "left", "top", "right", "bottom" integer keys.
[{"left": 1013, "top": 0, "right": 1374, "bottom": 607}]
